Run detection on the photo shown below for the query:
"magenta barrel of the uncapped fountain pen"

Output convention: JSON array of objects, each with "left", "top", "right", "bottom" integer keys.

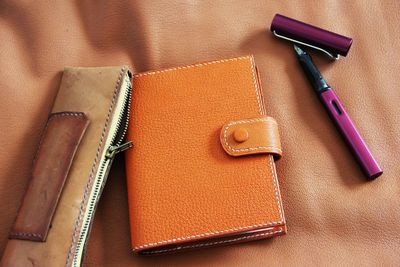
[{"left": 320, "top": 89, "right": 383, "bottom": 179}]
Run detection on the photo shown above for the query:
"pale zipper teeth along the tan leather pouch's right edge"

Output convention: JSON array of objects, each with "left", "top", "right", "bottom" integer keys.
[{"left": 73, "top": 75, "right": 132, "bottom": 266}]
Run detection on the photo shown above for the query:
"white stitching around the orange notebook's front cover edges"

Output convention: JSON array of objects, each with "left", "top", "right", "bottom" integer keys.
[{"left": 133, "top": 56, "right": 283, "bottom": 251}]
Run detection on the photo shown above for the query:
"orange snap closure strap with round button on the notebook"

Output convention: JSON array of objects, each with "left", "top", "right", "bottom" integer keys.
[{"left": 220, "top": 117, "right": 282, "bottom": 159}]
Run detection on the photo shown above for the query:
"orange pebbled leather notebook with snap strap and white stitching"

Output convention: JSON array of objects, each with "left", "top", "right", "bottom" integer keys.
[{"left": 126, "top": 56, "right": 286, "bottom": 255}]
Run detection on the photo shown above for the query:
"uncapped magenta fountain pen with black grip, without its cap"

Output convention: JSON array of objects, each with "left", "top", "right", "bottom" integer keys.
[{"left": 294, "top": 45, "right": 383, "bottom": 179}]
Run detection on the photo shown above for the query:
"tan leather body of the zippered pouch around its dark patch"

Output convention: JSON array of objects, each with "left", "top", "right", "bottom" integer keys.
[{"left": 0, "top": 67, "right": 127, "bottom": 267}]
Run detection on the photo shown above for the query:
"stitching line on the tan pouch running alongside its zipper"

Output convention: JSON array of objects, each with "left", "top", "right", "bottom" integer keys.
[{"left": 65, "top": 66, "right": 126, "bottom": 266}]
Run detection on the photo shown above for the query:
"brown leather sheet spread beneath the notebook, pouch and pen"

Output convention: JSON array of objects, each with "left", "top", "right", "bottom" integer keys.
[{"left": 0, "top": 0, "right": 400, "bottom": 266}]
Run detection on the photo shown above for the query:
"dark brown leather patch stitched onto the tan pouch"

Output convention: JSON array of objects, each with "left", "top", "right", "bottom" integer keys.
[{"left": 9, "top": 112, "right": 89, "bottom": 242}]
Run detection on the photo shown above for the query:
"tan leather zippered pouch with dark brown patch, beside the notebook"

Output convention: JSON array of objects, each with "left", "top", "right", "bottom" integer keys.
[{"left": 1, "top": 67, "right": 132, "bottom": 266}]
